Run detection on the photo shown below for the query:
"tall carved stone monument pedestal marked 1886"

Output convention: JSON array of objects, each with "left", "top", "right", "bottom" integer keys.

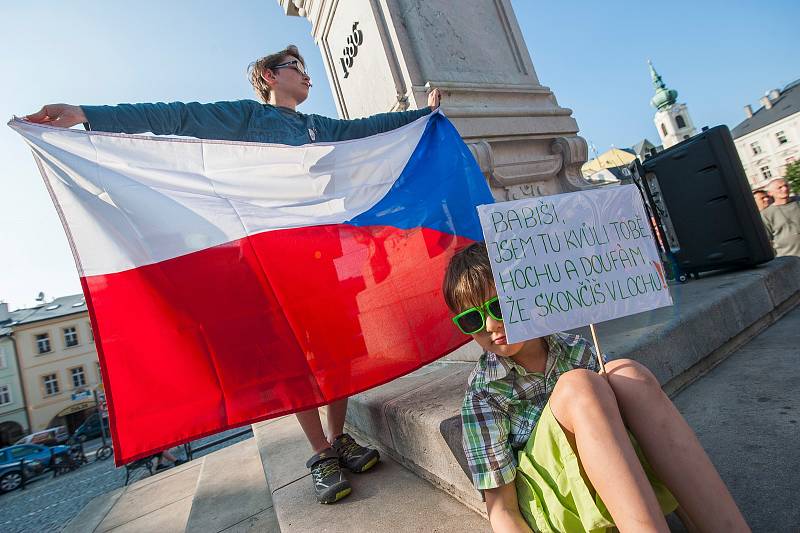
[{"left": 278, "top": 0, "right": 590, "bottom": 200}]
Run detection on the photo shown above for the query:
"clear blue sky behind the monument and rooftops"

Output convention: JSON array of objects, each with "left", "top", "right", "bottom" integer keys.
[{"left": 0, "top": 0, "right": 800, "bottom": 308}]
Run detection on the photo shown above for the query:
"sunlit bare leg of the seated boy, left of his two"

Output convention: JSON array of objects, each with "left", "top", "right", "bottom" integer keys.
[{"left": 550, "top": 369, "right": 669, "bottom": 533}]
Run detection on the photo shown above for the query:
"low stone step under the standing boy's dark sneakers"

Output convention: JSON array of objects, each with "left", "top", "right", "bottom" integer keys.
[{"left": 253, "top": 416, "right": 490, "bottom": 533}]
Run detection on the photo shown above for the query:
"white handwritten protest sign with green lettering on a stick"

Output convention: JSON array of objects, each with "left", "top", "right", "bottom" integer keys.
[{"left": 478, "top": 185, "right": 672, "bottom": 342}]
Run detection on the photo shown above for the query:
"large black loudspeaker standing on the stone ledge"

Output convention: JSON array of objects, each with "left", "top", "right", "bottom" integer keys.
[{"left": 633, "top": 126, "right": 775, "bottom": 275}]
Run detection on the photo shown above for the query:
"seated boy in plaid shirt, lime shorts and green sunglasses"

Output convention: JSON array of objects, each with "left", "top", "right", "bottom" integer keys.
[{"left": 444, "top": 243, "right": 749, "bottom": 532}]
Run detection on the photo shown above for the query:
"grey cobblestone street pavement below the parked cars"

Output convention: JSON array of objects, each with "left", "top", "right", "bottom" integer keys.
[{"left": 0, "top": 430, "right": 252, "bottom": 533}]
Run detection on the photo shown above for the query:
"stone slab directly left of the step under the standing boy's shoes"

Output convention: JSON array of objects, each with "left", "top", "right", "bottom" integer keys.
[{"left": 186, "top": 439, "right": 280, "bottom": 533}]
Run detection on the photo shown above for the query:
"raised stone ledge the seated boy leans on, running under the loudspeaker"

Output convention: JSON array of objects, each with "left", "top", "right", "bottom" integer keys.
[{"left": 342, "top": 257, "right": 800, "bottom": 515}]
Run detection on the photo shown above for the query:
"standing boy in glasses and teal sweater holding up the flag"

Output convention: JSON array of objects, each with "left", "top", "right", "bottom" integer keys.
[{"left": 25, "top": 45, "right": 441, "bottom": 503}]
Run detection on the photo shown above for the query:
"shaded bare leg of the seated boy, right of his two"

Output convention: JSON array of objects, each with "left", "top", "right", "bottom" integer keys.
[{"left": 606, "top": 359, "right": 749, "bottom": 532}]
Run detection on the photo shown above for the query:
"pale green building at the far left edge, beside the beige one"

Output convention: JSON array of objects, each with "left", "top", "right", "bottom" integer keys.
[{"left": 0, "top": 302, "right": 30, "bottom": 448}]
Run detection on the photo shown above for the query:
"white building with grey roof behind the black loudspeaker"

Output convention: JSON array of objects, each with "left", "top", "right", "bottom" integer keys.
[{"left": 731, "top": 80, "right": 800, "bottom": 188}]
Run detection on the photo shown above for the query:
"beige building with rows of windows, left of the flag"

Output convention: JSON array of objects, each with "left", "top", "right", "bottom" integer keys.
[{"left": 13, "top": 294, "right": 102, "bottom": 433}]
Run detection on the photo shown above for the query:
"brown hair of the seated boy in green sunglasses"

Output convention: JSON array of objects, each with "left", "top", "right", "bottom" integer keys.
[{"left": 442, "top": 242, "right": 494, "bottom": 313}]
